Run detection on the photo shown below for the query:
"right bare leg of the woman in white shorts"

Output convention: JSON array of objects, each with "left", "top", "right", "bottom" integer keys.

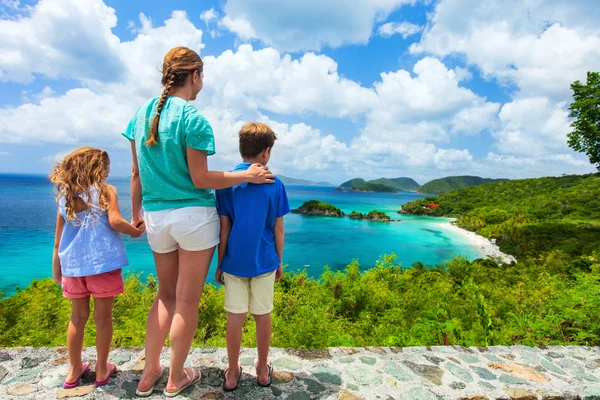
[{"left": 166, "top": 247, "right": 215, "bottom": 392}]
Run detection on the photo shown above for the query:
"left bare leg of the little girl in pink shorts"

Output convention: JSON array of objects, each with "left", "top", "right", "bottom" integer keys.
[{"left": 65, "top": 297, "right": 90, "bottom": 383}]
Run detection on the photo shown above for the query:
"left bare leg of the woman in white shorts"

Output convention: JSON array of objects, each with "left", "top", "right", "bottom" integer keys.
[{"left": 138, "top": 251, "right": 179, "bottom": 392}]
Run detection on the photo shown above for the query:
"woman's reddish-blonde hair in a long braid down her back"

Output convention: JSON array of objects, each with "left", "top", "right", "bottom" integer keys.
[{"left": 146, "top": 47, "right": 204, "bottom": 147}]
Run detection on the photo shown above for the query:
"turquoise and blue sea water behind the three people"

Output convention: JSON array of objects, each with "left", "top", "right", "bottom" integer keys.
[{"left": 0, "top": 174, "right": 481, "bottom": 294}]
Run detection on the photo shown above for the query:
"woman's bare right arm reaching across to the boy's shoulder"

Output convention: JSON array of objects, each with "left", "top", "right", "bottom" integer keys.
[{"left": 187, "top": 147, "right": 275, "bottom": 189}]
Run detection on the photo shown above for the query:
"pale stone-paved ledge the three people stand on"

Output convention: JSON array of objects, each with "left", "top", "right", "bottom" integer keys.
[{"left": 0, "top": 346, "right": 600, "bottom": 400}]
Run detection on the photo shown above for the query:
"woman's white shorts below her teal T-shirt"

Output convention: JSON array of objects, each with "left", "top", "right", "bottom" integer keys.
[{"left": 144, "top": 207, "right": 221, "bottom": 253}]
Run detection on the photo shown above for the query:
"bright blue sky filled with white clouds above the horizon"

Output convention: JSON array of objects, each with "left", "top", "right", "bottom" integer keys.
[{"left": 0, "top": 0, "right": 600, "bottom": 183}]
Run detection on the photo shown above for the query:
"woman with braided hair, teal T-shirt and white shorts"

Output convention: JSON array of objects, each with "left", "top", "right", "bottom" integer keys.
[{"left": 123, "top": 47, "right": 274, "bottom": 397}]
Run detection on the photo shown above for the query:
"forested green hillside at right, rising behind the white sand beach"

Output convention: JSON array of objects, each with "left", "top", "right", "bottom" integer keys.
[{"left": 402, "top": 174, "right": 600, "bottom": 259}]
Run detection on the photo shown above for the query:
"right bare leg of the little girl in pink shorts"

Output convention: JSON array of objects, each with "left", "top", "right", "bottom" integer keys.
[{"left": 94, "top": 297, "right": 114, "bottom": 382}]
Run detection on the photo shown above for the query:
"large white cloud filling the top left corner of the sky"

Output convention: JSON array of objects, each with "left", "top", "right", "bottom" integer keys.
[{"left": 0, "top": 0, "right": 124, "bottom": 83}]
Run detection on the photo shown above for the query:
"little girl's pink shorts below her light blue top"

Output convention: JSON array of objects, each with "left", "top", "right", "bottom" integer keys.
[{"left": 62, "top": 268, "right": 125, "bottom": 299}]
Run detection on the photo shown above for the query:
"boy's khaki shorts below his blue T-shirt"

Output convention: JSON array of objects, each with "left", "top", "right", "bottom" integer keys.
[{"left": 223, "top": 271, "right": 276, "bottom": 315}]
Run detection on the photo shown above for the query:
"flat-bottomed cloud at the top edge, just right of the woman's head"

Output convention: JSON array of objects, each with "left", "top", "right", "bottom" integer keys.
[{"left": 222, "top": 0, "right": 415, "bottom": 52}]
